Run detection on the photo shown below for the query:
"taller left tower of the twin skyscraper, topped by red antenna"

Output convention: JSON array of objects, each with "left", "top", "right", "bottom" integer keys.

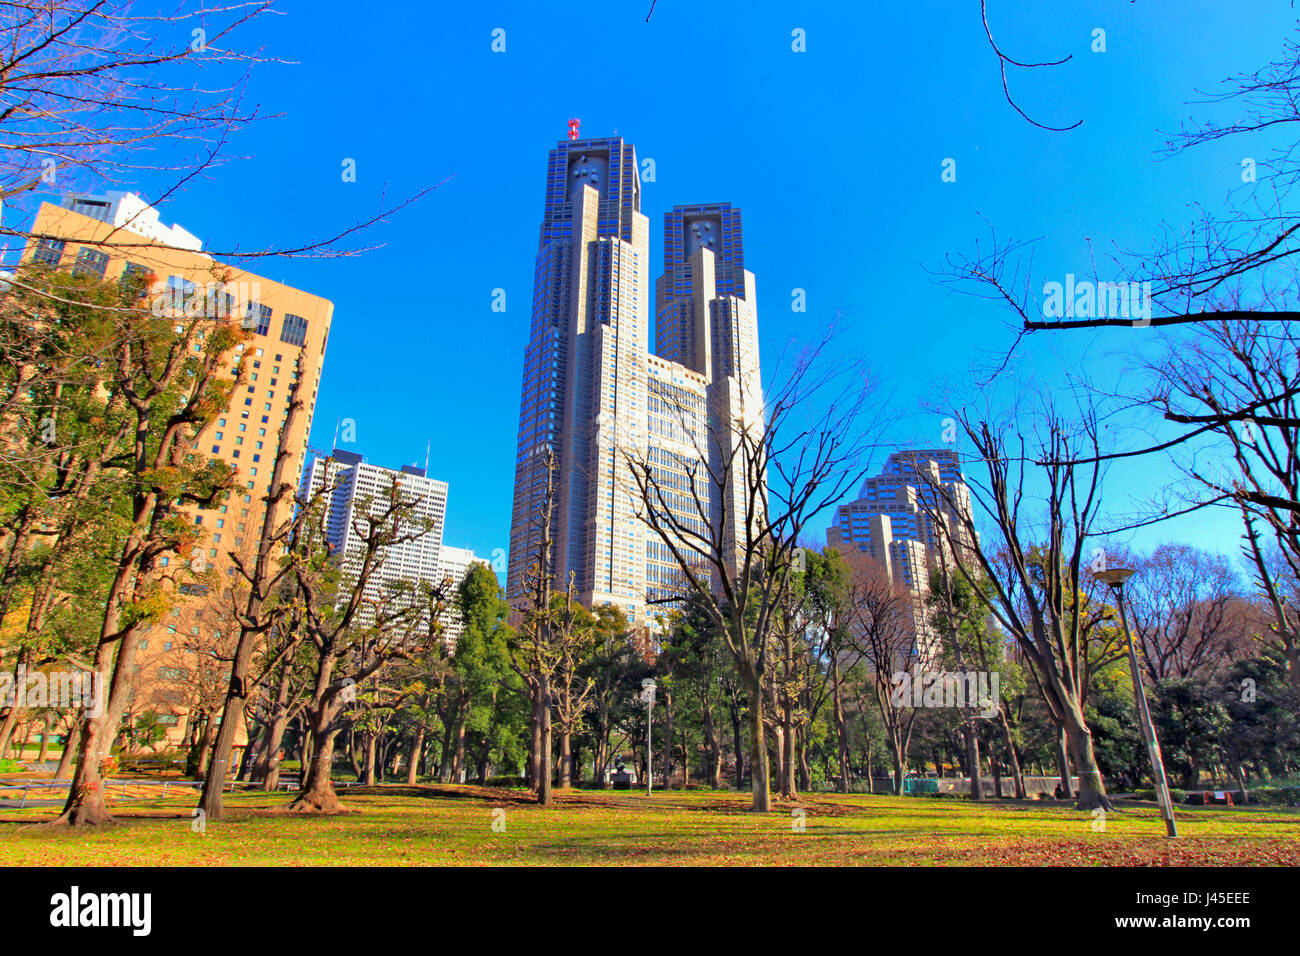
[{"left": 507, "top": 138, "right": 650, "bottom": 624}]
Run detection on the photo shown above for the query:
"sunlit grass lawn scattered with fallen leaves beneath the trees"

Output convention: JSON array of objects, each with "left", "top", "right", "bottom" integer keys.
[{"left": 0, "top": 786, "right": 1300, "bottom": 866}]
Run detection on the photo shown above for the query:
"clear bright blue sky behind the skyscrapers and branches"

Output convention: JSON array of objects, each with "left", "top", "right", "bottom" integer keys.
[{"left": 40, "top": 0, "right": 1295, "bottom": 567}]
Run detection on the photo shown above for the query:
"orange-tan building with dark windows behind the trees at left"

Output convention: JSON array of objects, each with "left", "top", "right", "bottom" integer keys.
[{"left": 25, "top": 193, "right": 334, "bottom": 745}]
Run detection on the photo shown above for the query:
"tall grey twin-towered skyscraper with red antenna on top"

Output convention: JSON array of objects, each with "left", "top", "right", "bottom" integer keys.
[{"left": 506, "top": 138, "right": 762, "bottom": 623}]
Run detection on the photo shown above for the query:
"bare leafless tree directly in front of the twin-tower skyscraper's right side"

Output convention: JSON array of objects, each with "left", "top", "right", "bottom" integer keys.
[{"left": 621, "top": 338, "right": 871, "bottom": 812}]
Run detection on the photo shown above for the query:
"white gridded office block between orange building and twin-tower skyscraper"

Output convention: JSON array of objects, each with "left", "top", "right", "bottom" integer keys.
[{"left": 302, "top": 449, "right": 447, "bottom": 632}]
